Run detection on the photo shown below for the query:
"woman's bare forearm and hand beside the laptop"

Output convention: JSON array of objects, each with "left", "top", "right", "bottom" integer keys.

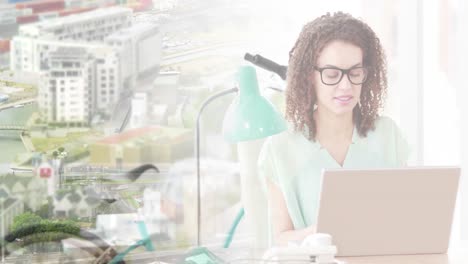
[{"left": 266, "top": 179, "right": 315, "bottom": 246}]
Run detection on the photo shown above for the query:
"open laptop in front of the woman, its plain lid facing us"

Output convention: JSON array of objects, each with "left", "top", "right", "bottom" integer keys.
[{"left": 317, "top": 167, "right": 460, "bottom": 256}]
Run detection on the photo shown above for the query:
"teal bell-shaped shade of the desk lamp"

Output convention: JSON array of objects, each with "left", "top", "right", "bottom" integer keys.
[{"left": 223, "top": 66, "right": 287, "bottom": 143}]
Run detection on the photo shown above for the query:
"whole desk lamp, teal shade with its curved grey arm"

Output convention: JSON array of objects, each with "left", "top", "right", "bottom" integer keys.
[{"left": 195, "top": 66, "right": 287, "bottom": 247}]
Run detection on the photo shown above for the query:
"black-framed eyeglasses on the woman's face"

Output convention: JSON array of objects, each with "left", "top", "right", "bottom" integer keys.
[{"left": 314, "top": 67, "right": 368, "bottom": 85}]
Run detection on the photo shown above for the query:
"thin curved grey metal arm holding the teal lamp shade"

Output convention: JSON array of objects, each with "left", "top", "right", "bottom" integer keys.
[{"left": 195, "top": 87, "right": 239, "bottom": 247}]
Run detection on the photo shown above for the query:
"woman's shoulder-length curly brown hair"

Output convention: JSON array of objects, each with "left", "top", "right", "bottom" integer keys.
[{"left": 286, "top": 12, "right": 387, "bottom": 140}]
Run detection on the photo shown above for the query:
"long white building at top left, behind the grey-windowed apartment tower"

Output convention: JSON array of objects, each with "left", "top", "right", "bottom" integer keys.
[{"left": 10, "top": 7, "right": 132, "bottom": 72}]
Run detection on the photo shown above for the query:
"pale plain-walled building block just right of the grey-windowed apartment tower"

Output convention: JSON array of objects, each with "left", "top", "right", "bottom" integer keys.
[{"left": 105, "top": 23, "right": 162, "bottom": 88}]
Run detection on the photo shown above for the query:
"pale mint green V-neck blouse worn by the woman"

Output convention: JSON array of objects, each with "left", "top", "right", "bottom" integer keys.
[{"left": 258, "top": 117, "right": 409, "bottom": 229}]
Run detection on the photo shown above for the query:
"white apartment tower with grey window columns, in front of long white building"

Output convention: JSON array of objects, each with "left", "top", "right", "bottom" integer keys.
[{"left": 37, "top": 40, "right": 121, "bottom": 124}]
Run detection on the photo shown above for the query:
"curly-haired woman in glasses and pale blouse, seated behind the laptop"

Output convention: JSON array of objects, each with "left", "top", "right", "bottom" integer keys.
[{"left": 259, "top": 10, "right": 408, "bottom": 244}]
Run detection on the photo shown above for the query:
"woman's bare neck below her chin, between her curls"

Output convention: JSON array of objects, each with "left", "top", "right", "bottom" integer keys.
[{"left": 314, "top": 109, "right": 354, "bottom": 140}]
